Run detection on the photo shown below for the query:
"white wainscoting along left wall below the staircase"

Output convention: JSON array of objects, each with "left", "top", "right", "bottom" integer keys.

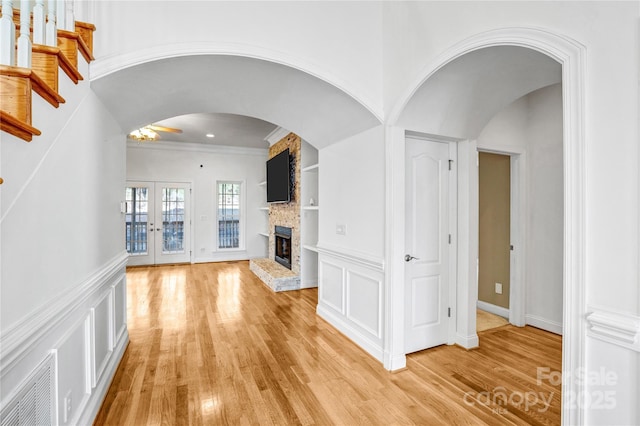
[{"left": 0, "top": 252, "right": 129, "bottom": 425}]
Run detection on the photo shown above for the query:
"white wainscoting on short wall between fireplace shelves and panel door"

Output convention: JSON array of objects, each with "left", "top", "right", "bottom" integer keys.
[{"left": 317, "top": 247, "right": 384, "bottom": 362}]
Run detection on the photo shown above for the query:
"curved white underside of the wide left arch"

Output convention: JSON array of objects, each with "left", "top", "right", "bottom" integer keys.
[{"left": 91, "top": 55, "right": 380, "bottom": 148}]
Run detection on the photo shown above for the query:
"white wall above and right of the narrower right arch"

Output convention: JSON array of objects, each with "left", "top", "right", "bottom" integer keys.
[{"left": 384, "top": 1, "right": 640, "bottom": 313}]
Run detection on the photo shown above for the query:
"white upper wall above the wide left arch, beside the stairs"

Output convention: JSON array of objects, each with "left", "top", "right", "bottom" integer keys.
[{"left": 92, "top": 1, "right": 382, "bottom": 120}]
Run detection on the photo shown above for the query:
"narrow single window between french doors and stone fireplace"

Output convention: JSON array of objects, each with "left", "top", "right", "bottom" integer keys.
[{"left": 218, "top": 182, "right": 242, "bottom": 249}]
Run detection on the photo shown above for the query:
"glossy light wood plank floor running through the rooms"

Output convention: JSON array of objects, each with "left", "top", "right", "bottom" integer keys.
[{"left": 95, "top": 262, "right": 561, "bottom": 425}]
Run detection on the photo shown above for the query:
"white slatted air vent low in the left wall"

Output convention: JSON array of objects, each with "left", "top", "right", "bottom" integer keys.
[{"left": 0, "top": 353, "right": 56, "bottom": 426}]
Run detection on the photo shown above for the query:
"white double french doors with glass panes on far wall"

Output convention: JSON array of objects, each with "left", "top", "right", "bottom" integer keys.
[{"left": 125, "top": 182, "right": 191, "bottom": 265}]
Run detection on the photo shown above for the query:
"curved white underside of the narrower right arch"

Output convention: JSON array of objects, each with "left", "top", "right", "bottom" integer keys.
[{"left": 399, "top": 46, "right": 562, "bottom": 139}]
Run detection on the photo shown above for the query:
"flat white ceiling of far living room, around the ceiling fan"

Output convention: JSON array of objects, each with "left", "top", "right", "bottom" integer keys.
[{"left": 140, "top": 113, "right": 277, "bottom": 148}]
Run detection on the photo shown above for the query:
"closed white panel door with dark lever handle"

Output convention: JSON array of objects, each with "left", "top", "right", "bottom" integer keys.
[{"left": 405, "top": 138, "right": 450, "bottom": 353}]
